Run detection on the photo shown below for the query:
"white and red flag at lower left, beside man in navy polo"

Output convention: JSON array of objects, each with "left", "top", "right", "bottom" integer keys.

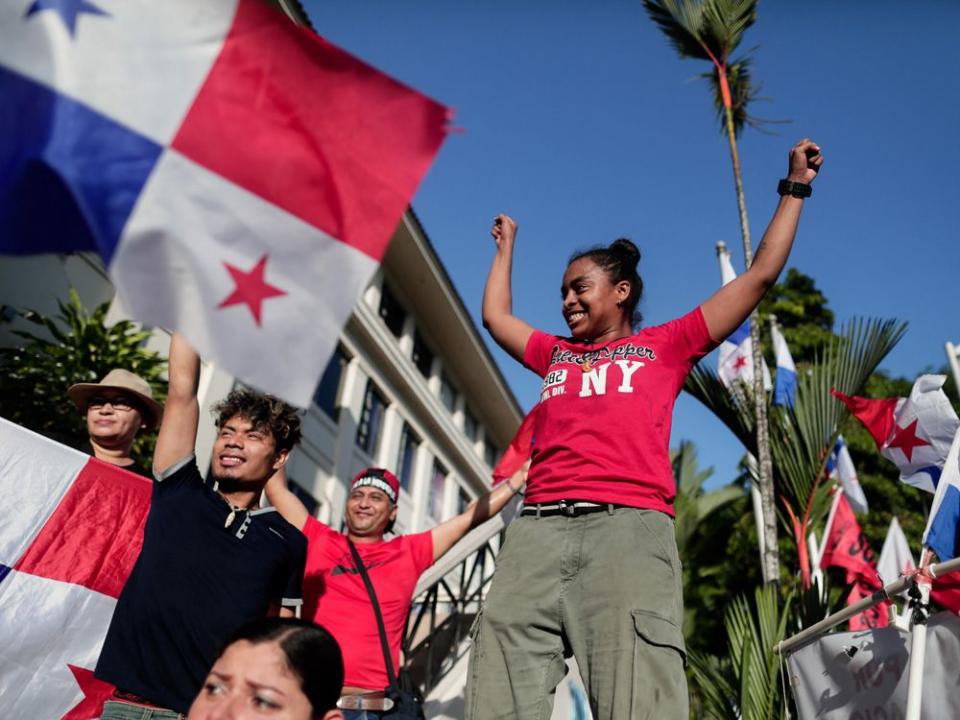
[{"left": 0, "top": 419, "right": 151, "bottom": 720}]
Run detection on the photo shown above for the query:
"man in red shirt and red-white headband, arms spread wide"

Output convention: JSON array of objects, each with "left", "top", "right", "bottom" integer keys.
[{"left": 266, "top": 468, "right": 526, "bottom": 717}]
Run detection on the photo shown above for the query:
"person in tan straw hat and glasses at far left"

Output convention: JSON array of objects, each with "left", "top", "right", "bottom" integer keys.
[{"left": 67, "top": 368, "right": 163, "bottom": 477}]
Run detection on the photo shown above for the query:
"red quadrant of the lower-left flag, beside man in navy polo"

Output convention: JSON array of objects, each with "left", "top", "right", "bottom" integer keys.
[{"left": 15, "top": 458, "right": 153, "bottom": 597}]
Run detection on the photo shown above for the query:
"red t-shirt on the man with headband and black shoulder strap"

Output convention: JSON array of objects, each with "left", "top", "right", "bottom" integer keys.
[{"left": 303, "top": 516, "right": 433, "bottom": 690}]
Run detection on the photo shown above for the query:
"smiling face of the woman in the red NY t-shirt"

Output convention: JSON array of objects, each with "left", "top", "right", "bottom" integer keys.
[{"left": 560, "top": 258, "right": 630, "bottom": 340}]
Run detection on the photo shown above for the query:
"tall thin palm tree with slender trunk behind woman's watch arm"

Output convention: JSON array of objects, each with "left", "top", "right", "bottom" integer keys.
[{"left": 643, "top": 0, "right": 780, "bottom": 583}]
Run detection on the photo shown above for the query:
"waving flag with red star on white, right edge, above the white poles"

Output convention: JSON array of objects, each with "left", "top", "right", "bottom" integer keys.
[{"left": 831, "top": 375, "right": 960, "bottom": 493}]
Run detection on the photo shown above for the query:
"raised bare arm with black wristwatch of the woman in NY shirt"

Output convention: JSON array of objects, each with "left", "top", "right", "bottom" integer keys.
[{"left": 701, "top": 139, "right": 823, "bottom": 341}]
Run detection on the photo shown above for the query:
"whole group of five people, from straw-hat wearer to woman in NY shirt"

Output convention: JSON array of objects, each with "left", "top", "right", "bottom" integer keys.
[{"left": 69, "top": 140, "right": 823, "bottom": 720}]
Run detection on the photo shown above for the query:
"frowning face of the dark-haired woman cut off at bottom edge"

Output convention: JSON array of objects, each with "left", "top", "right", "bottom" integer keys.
[{"left": 187, "top": 640, "right": 314, "bottom": 720}]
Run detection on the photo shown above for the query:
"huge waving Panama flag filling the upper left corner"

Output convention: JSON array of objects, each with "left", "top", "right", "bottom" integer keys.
[{"left": 0, "top": 0, "right": 448, "bottom": 405}]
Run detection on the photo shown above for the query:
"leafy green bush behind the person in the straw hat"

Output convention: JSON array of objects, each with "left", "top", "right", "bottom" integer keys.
[{"left": 0, "top": 290, "right": 166, "bottom": 467}]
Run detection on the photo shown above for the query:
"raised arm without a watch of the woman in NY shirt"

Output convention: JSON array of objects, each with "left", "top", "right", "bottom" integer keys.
[{"left": 483, "top": 214, "right": 533, "bottom": 362}]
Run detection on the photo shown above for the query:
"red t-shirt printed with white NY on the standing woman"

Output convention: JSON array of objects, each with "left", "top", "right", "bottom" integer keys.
[{"left": 524, "top": 307, "right": 717, "bottom": 515}]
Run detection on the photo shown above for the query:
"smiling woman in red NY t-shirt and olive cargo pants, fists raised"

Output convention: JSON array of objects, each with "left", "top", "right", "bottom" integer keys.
[{"left": 466, "top": 140, "right": 823, "bottom": 720}]
